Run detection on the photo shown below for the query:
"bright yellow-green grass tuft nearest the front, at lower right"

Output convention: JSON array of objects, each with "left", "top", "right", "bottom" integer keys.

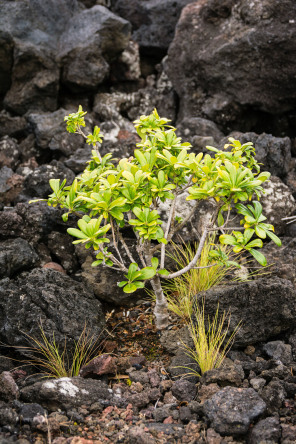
[{"left": 183, "top": 303, "right": 240, "bottom": 376}]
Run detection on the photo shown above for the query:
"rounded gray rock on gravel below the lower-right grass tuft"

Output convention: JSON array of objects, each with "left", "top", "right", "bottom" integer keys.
[{"left": 203, "top": 387, "right": 266, "bottom": 435}]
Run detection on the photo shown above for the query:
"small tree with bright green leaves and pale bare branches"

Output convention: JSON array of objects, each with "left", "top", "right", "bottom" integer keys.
[{"left": 40, "top": 106, "right": 281, "bottom": 329}]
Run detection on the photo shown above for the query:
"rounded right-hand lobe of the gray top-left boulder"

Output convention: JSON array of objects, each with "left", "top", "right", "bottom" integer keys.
[{"left": 59, "top": 5, "right": 131, "bottom": 90}]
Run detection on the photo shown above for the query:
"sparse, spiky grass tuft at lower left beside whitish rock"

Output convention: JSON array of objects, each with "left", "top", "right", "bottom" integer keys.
[{"left": 18, "top": 325, "right": 101, "bottom": 378}]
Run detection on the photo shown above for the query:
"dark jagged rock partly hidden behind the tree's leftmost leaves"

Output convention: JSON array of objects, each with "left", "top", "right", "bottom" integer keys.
[{"left": 24, "top": 160, "right": 75, "bottom": 198}]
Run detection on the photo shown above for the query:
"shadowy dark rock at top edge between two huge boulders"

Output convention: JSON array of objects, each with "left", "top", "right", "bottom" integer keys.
[{"left": 113, "top": 0, "right": 190, "bottom": 55}]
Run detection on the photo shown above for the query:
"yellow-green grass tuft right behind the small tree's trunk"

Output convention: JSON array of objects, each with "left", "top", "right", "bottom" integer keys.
[{"left": 163, "top": 236, "right": 237, "bottom": 322}]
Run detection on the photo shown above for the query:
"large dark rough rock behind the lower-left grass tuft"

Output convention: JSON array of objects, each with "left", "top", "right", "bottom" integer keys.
[{"left": 0, "top": 269, "right": 104, "bottom": 354}]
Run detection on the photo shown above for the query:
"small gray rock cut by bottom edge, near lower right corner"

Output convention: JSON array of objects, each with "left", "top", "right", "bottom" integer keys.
[{"left": 248, "top": 416, "right": 281, "bottom": 444}]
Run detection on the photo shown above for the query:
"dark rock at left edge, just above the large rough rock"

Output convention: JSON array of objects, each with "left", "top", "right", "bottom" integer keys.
[{"left": 0, "top": 238, "right": 39, "bottom": 279}]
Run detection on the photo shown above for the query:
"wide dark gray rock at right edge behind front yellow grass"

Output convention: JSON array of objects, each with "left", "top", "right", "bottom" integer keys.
[{"left": 197, "top": 277, "right": 296, "bottom": 346}]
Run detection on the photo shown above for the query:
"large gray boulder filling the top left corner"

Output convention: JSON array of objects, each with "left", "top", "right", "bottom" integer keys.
[{"left": 0, "top": 0, "right": 131, "bottom": 114}]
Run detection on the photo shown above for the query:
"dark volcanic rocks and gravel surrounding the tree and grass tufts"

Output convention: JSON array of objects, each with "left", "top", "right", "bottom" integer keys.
[{"left": 0, "top": 0, "right": 296, "bottom": 444}]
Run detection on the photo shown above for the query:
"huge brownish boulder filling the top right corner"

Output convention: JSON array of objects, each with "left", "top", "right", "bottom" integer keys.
[{"left": 167, "top": 0, "right": 296, "bottom": 129}]
